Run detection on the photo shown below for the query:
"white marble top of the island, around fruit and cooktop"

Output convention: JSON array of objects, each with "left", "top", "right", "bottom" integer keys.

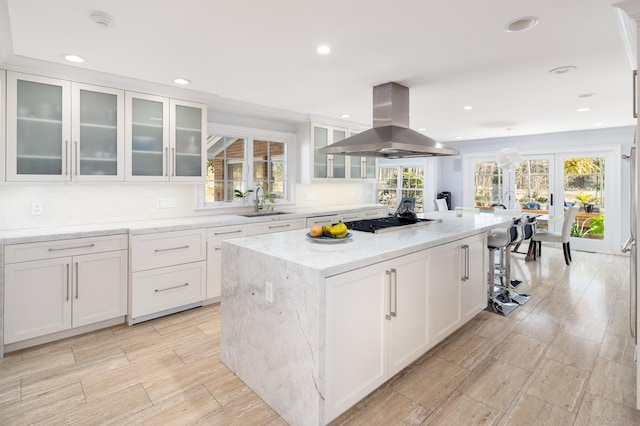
[{"left": 223, "top": 211, "right": 511, "bottom": 277}]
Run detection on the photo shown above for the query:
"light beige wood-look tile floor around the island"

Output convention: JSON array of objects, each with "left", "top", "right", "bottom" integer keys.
[{"left": 0, "top": 247, "right": 640, "bottom": 425}]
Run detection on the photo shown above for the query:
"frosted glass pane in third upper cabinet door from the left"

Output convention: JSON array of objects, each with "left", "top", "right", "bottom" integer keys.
[{"left": 130, "top": 98, "right": 168, "bottom": 177}]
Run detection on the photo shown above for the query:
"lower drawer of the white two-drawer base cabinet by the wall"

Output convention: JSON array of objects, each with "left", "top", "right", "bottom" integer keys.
[{"left": 131, "top": 261, "right": 207, "bottom": 319}]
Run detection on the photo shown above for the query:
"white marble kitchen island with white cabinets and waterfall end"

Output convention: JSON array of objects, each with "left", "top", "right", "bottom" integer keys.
[{"left": 221, "top": 212, "right": 509, "bottom": 425}]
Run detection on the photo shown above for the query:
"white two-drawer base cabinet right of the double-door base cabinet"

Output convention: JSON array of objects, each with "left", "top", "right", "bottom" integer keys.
[{"left": 128, "top": 229, "right": 207, "bottom": 325}]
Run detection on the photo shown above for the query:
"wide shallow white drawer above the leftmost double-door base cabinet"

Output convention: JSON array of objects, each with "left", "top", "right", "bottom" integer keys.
[{"left": 4, "top": 234, "right": 127, "bottom": 263}]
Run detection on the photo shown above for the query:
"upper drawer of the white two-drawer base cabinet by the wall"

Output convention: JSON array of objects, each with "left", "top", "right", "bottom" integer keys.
[{"left": 131, "top": 229, "right": 207, "bottom": 272}]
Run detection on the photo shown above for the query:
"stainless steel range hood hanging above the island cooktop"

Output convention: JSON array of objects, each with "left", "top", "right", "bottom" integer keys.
[{"left": 319, "top": 83, "right": 459, "bottom": 158}]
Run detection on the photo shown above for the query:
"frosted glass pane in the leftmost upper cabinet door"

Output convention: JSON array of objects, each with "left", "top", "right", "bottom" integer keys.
[{"left": 16, "top": 79, "right": 65, "bottom": 176}]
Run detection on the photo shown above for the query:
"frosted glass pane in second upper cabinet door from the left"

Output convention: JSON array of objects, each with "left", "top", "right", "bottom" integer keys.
[{"left": 74, "top": 90, "right": 120, "bottom": 176}]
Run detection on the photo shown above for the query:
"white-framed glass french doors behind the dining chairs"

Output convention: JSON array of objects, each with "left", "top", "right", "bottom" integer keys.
[{"left": 465, "top": 146, "right": 621, "bottom": 253}]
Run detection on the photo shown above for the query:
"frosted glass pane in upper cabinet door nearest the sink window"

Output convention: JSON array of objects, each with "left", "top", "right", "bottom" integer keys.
[{"left": 173, "top": 105, "right": 203, "bottom": 177}]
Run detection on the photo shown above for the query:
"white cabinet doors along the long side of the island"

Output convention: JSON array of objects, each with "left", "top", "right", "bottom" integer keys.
[{"left": 324, "top": 234, "right": 487, "bottom": 422}]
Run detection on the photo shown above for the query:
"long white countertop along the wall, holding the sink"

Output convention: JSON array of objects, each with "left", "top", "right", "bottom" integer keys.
[{"left": 0, "top": 205, "right": 382, "bottom": 244}]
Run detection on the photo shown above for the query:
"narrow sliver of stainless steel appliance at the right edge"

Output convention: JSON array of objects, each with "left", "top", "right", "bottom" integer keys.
[{"left": 621, "top": 147, "right": 638, "bottom": 345}]
